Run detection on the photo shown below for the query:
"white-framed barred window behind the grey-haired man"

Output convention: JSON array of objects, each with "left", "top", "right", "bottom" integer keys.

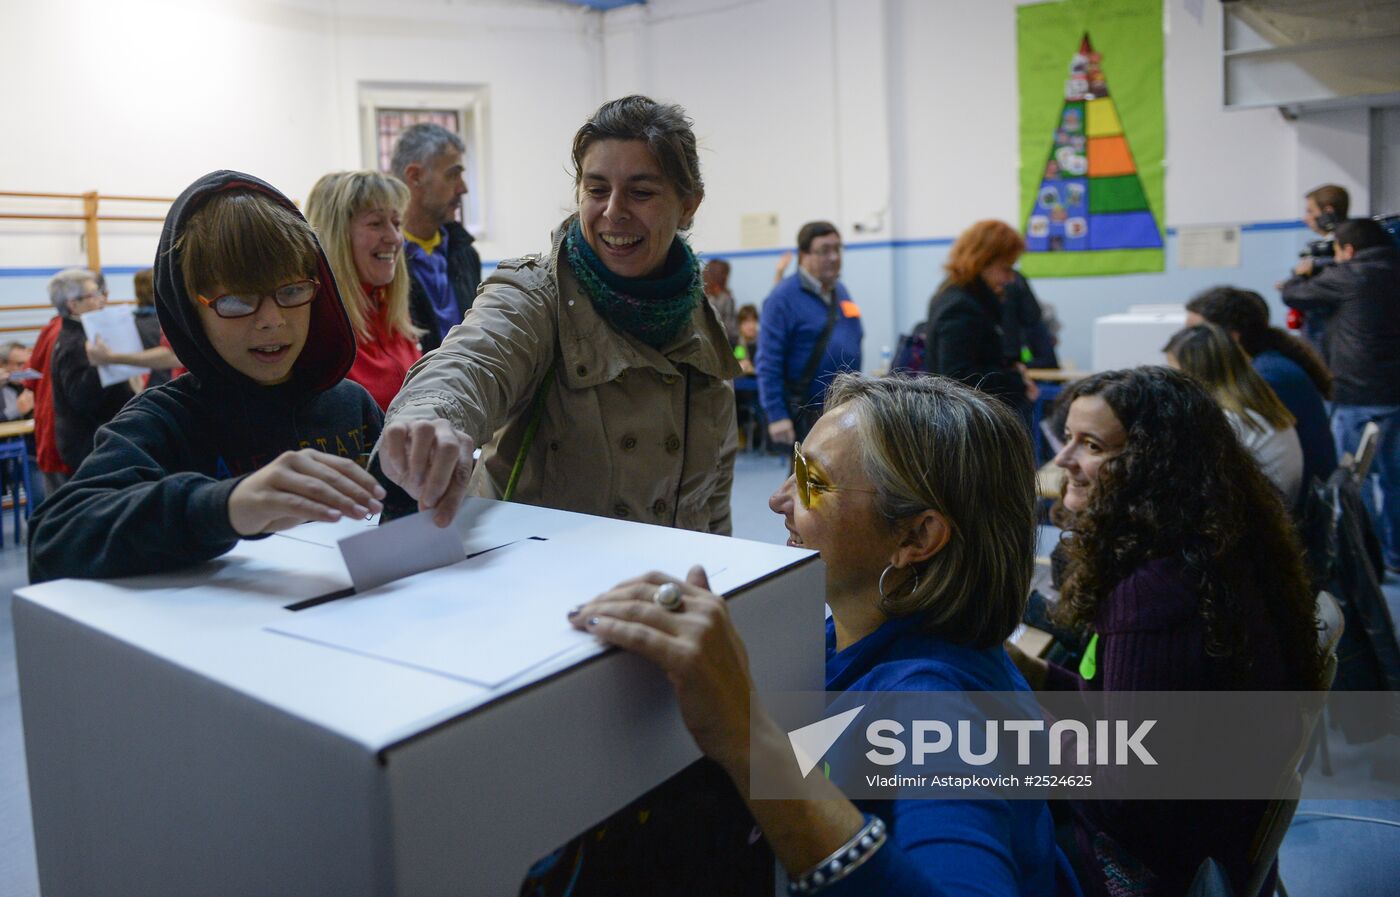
[{"left": 360, "top": 84, "right": 490, "bottom": 238}]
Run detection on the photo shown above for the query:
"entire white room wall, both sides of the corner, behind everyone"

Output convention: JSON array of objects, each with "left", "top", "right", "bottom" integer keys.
[{"left": 0, "top": 0, "right": 1396, "bottom": 364}]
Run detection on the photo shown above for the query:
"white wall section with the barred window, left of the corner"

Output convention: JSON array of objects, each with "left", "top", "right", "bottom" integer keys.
[{"left": 0, "top": 0, "right": 602, "bottom": 274}]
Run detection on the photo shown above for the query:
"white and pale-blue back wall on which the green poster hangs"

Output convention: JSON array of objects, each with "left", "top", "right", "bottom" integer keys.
[{"left": 603, "top": 0, "right": 1394, "bottom": 367}]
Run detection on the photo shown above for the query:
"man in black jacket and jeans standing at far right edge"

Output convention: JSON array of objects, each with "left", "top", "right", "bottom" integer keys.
[{"left": 1282, "top": 218, "right": 1400, "bottom": 572}]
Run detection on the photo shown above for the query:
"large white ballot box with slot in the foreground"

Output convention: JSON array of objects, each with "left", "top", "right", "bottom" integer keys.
[{"left": 14, "top": 500, "right": 825, "bottom": 897}]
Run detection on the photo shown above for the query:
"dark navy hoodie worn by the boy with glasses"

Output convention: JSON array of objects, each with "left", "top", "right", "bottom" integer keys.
[{"left": 29, "top": 171, "right": 397, "bottom": 582}]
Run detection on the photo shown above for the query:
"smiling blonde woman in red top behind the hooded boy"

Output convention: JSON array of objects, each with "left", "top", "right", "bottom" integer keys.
[{"left": 307, "top": 171, "right": 421, "bottom": 409}]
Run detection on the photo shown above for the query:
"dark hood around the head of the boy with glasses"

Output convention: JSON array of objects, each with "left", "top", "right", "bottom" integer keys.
[{"left": 155, "top": 171, "right": 354, "bottom": 393}]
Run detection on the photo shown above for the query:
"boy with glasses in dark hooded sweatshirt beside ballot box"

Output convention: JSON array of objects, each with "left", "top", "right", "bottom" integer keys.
[{"left": 29, "top": 171, "right": 406, "bottom": 582}]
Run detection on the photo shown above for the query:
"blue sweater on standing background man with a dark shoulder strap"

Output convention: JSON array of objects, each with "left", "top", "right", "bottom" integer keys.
[{"left": 757, "top": 274, "right": 865, "bottom": 421}]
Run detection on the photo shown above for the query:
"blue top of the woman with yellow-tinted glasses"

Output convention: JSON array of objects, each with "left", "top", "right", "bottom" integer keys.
[{"left": 823, "top": 617, "right": 1081, "bottom": 897}]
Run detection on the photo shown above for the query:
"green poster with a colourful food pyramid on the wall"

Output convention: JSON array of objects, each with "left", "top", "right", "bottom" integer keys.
[{"left": 1016, "top": 0, "right": 1166, "bottom": 277}]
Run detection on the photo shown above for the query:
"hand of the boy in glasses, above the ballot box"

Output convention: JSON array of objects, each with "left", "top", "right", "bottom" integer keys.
[{"left": 228, "top": 449, "right": 384, "bottom": 536}]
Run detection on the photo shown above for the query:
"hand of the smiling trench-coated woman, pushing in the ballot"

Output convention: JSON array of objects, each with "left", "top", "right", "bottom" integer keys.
[{"left": 379, "top": 418, "right": 476, "bottom": 526}]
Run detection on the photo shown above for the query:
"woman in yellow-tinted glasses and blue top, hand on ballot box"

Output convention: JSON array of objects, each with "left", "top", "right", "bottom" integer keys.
[{"left": 571, "top": 374, "right": 1078, "bottom": 896}]
